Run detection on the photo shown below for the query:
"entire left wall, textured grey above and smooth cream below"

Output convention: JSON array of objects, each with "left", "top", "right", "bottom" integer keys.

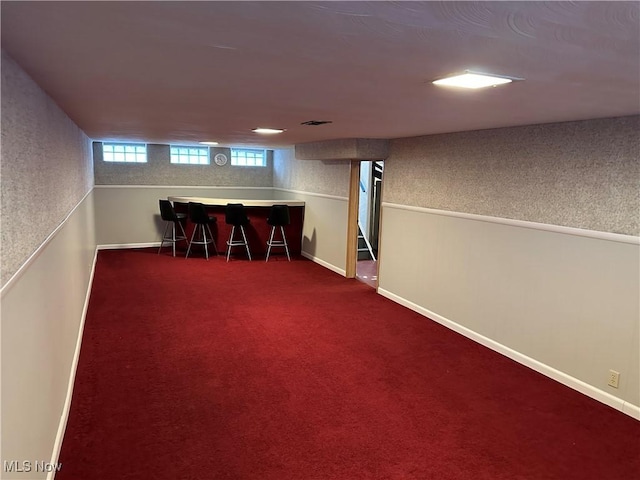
[{"left": 0, "top": 52, "right": 96, "bottom": 480}]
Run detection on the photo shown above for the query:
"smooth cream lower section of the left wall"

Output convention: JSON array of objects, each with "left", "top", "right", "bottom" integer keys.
[{"left": 0, "top": 194, "right": 96, "bottom": 480}]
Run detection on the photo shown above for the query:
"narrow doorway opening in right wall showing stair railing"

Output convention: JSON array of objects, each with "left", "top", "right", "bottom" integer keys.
[{"left": 356, "top": 161, "right": 384, "bottom": 288}]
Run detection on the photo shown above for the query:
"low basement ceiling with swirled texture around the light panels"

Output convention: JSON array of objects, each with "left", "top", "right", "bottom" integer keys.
[{"left": 1, "top": 1, "right": 640, "bottom": 147}]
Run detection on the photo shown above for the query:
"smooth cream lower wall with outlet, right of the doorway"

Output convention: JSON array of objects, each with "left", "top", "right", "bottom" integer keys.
[{"left": 379, "top": 204, "right": 640, "bottom": 418}]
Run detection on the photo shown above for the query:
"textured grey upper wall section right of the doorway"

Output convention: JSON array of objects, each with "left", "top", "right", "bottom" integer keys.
[{"left": 383, "top": 116, "right": 640, "bottom": 235}]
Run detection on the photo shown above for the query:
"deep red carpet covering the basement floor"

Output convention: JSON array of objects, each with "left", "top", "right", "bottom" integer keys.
[{"left": 56, "top": 249, "right": 640, "bottom": 480}]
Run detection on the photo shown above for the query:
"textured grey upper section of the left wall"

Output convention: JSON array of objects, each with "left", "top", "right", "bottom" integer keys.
[{"left": 0, "top": 51, "right": 93, "bottom": 285}]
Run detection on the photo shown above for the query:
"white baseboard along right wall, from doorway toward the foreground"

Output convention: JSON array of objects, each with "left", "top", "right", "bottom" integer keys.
[{"left": 378, "top": 287, "right": 640, "bottom": 420}]
